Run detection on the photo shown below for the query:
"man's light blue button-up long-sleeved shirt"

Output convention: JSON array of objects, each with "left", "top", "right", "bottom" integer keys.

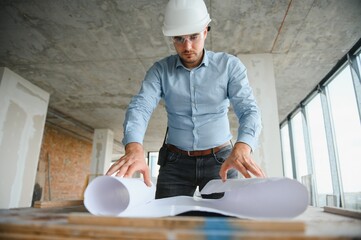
[{"left": 123, "top": 50, "right": 261, "bottom": 151}]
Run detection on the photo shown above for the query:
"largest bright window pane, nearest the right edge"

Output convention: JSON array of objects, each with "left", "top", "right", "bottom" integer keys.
[{"left": 327, "top": 66, "right": 361, "bottom": 208}]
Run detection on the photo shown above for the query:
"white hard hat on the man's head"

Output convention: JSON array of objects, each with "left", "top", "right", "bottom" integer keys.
[{"left": 162, "top": 0, "right": 211, "bottom": 36}]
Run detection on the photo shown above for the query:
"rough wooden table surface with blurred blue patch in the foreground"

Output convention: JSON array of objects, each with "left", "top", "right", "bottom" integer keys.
[{"left": 0, "top": 203, "right": 361, "bottom": 240}]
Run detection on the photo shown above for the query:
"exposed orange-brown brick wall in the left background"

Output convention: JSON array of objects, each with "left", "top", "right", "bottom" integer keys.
[{"left": 34, "top": 124, "right": 92, "bottom": 201}]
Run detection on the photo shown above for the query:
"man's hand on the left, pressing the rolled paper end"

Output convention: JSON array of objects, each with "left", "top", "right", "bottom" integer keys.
[{"left": 106, "top": 142, "right": 152, "bottom": 187}]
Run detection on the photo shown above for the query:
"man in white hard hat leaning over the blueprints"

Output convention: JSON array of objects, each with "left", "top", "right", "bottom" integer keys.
[{"left": 107, "top": 0, "right": 264, "bottom": 198}]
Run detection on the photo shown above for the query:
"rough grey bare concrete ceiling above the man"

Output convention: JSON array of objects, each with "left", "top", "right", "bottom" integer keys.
[{"left": 0, "top": 0, "right": 361, "bottom": 151}]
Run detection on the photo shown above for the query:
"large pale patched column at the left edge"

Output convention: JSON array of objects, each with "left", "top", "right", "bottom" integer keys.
[{"left": 0, "top": 68, "right": 49, "bottom": 208}]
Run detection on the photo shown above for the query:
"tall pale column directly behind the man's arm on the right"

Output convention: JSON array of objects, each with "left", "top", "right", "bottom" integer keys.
[{"left": 238, "top": 54, "right": 283, "bottom": 177}]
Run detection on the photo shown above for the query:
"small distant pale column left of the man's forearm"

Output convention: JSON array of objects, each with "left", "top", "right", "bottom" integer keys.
[{"left": 90, "top": 129, "right": 114, "bottom": 176}]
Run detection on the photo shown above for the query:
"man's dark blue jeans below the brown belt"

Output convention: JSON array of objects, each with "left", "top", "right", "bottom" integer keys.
[{"left": 155, "top": 145, "right": 238, "bottom": 199}]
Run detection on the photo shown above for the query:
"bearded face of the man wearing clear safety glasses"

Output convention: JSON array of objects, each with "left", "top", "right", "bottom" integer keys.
[{"left": 172, "top": 29, "right": 207, "bottom": 68}]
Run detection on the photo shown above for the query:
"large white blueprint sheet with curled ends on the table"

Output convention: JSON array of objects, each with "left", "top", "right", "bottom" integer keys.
[{"left": 84, "top": 176, "right": 308, "bottom": 219}]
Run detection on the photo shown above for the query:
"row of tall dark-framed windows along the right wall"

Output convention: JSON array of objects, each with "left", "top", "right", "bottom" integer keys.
[{"left": 280, "top": 40, "right": 361, "bottom": 209}]
